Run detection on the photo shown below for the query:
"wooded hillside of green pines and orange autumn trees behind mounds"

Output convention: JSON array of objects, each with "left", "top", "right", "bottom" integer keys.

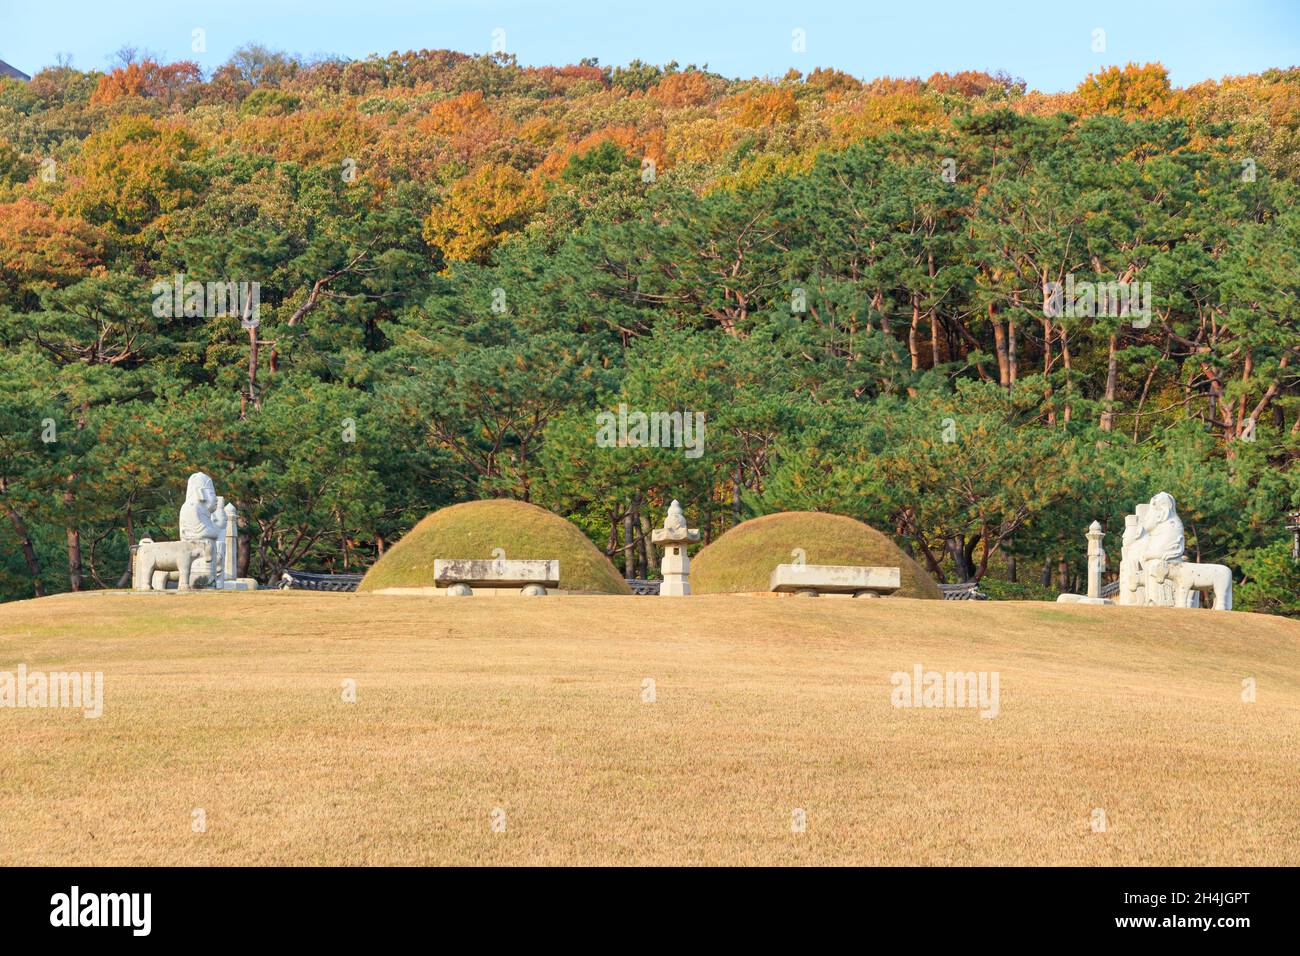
[{"left": 0, "top": 47, "right": 1300, "bottom": 613}]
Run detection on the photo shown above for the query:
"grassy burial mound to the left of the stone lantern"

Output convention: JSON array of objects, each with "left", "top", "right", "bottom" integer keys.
[{"left": 359, "top": 498, "right": 631, "bottom": 594}]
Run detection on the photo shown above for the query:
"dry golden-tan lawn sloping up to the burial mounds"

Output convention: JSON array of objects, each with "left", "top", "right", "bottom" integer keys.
[{"left": 0, "top": 592, "right": 1300, "bottom": 865}]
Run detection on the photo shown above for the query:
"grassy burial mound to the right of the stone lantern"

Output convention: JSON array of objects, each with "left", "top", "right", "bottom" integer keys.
[{"left": 690, "top": 511, "right": 943, "bottom": 600}]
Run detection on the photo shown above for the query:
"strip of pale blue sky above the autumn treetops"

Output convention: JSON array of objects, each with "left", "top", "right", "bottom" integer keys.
[{"left": 0, "top": 0, "right": 1300, "bottom": 92}]
